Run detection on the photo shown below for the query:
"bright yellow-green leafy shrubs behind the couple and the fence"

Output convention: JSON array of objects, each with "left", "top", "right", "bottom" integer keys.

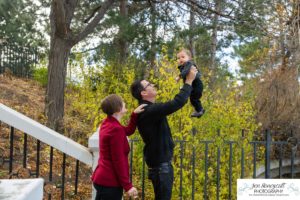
[{"left": 67, "top": 52, "right": 257, "bottom": 199}]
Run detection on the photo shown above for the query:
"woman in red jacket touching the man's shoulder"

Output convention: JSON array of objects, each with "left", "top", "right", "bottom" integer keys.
[{"left": 92, "top": 94, "right": 145, "bottom": 200}]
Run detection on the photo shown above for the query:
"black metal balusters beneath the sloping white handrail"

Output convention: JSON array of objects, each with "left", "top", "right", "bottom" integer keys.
[{"left": 0, "top": 121, "right": 91, "bottom": 200}]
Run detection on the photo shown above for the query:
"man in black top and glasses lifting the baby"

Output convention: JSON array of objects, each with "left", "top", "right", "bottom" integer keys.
[{"left": 130, "top": 67, "right": 197, "bottom": 200}]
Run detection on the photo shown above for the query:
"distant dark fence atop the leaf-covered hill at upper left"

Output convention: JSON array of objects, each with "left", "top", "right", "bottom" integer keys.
[{"left": 0, "top": 43, "right": 38, "bottom": 78}]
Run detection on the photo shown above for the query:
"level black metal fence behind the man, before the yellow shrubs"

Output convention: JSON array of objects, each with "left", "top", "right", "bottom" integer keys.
[{"left": 126, "top": 131, "right": 300, "bottom": 200}]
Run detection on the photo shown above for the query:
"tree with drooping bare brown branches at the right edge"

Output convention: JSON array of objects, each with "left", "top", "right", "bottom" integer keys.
[{"left": 257, "top": 0, "right": 300, "bottom": 136}]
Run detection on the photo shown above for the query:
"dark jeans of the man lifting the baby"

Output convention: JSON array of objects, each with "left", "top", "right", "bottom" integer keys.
[{"left": 148, "top": 162, "right": 174, "bottom": 200}]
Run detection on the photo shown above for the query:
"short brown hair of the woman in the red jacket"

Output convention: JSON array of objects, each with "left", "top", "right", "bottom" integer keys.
[{"left": 101, "top": 94, "right": 123, "bottom": 116}]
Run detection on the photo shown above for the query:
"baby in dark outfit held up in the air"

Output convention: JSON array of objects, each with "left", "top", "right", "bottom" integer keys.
[{"left": 176, "top": 49, "right": 205, "bottom": 118}]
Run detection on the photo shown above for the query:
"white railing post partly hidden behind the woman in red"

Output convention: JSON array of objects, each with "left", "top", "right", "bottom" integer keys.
[{"left": 89, "top": 129, "right": 99, "bottom": 199}]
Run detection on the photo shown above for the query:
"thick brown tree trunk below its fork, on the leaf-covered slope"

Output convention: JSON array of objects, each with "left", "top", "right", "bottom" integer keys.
[{"left": 45, "top": 37, "right": 71, "bottom": 131}]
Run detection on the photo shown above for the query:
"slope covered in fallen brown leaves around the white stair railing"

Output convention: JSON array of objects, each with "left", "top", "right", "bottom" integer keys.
[{"left": 0, "top": 75, "right": 92, "bottom": 199}]
